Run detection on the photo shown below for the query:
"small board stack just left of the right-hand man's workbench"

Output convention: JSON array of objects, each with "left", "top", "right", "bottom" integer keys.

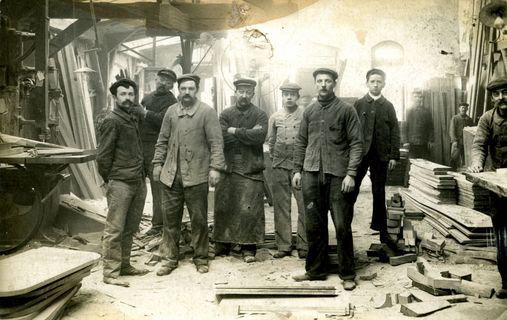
[{"left": 449, "top": 172, "right": 490, "bottom": 212}]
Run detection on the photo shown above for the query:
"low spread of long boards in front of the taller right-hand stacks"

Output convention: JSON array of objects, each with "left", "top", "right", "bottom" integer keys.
[{"left": 403, "top": 189, "right": 494, "bottom": 247}]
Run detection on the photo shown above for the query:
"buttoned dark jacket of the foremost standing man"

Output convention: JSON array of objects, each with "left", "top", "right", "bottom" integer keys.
[{"left": 294, "top": 97, "right": 363, "bottom": 177}]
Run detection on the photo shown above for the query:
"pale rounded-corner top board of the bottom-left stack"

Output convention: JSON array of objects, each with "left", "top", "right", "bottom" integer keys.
[{"left": 0, "top": 247, "right": 100, "bottom": 297}]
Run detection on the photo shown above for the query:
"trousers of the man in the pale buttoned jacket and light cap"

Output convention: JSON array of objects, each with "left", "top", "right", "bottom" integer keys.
[{"left": 271, "top": 168, "right": 308, "bottom": 251}]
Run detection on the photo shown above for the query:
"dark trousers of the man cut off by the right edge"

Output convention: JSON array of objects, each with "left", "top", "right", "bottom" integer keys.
[{"left": 490, "top": 192, "right": 507, "bottom": 289}]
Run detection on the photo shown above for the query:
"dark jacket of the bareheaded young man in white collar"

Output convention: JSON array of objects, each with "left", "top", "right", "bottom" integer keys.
[{"left": 354, "top": 94, "right": 400, "bottom": 161}]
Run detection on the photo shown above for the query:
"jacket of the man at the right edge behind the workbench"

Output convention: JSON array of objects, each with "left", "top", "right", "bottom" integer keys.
[{"left": 472, "top": 108, "right": 507, "bottom": 169}]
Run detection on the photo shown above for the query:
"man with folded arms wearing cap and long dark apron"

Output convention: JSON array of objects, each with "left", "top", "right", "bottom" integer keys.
[{"left": 213, "top": 78, "right": 268, "bottom": 263}]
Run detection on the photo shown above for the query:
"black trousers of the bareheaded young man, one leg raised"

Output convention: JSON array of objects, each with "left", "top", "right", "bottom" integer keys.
[{"left": 353, "top": 152, "right": 389, "bottom": 234}]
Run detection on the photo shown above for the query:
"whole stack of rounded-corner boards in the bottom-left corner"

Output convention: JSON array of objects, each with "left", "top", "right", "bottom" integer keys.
[{"left": 0, "top": 247, "right": 100, "bottom": 320}]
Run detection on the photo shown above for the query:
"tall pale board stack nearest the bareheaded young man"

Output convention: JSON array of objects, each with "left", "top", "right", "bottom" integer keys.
[{"left": 409, "top": 159, "right": 456, "bottom": 204}]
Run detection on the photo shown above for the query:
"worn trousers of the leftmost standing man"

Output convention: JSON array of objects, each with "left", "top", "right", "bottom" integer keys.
[{"left": 102, "top": 178, "right": 146, "bottom": 278}]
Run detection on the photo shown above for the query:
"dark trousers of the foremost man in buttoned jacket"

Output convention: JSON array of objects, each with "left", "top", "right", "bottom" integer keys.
[{"left": 302, "top": 171, "right": 356, "bottom": 280}]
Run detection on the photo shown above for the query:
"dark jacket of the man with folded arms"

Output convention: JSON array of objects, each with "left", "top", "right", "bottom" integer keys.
[{"left": 220, "top": 104, "right": 268, "bottom": 179}]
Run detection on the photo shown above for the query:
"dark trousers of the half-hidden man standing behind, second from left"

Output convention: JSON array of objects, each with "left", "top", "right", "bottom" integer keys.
[{"left": 143, "top": 141, "right": 163, "bottom": 228}]
